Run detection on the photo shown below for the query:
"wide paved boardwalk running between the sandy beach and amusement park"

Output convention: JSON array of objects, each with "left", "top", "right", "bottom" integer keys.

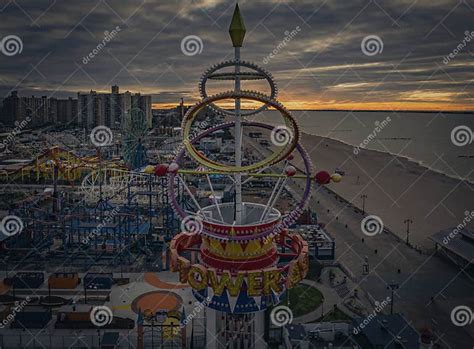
[{"left": 250, "top": 135, "right": 474, "bottom": 349}]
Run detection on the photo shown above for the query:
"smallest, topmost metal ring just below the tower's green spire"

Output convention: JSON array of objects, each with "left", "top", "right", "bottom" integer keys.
[{"left": 199, "top": 60, "right": 278, "bottom": 116}]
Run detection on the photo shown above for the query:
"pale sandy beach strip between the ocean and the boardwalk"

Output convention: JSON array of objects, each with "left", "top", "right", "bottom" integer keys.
[{"left": 302, "top": 134, "right": 474, "bottom": 249}]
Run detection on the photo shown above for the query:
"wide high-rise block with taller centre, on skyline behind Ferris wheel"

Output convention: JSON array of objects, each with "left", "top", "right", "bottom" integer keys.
[{"left": 77, "top": 85, "right": 152, "bottom": 128}]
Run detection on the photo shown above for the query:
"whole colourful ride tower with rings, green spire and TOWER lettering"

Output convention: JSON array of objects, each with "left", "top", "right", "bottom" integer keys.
[{"left": 167, "top": 6, "right": 336, "bottom": 349}]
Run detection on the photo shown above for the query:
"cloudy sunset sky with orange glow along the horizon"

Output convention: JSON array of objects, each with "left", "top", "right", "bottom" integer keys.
[{"left": 0, "top": 0, "right": 474, "bottom": 111}]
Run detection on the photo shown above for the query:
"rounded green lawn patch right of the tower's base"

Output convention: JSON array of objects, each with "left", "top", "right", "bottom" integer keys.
[{"left": 281, "top": 284, "right": 324, "bottom": 317}]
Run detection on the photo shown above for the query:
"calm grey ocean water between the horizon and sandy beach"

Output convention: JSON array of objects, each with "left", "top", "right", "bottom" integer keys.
[{"left": 253, "top": 111, "right": 474, "bottom": 183}]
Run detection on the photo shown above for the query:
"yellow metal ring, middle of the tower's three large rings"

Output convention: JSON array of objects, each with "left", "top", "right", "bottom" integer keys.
[{"left": 181, "top": 91, "right": 300, "bottom": 173}]
